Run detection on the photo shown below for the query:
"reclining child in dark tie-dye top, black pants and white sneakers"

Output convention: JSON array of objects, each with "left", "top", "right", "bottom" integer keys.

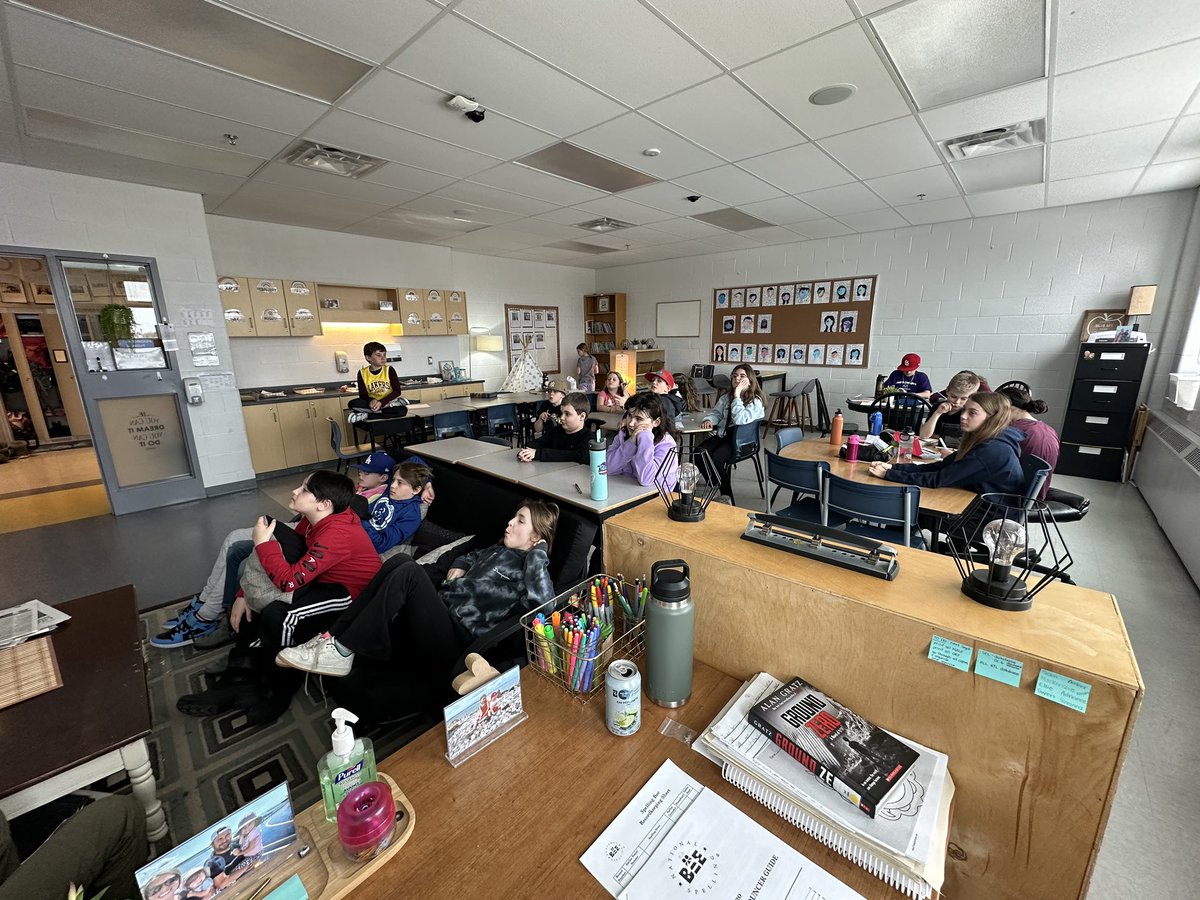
[{"left": 275, "top": 500, "right": 558, "bottom": 680}]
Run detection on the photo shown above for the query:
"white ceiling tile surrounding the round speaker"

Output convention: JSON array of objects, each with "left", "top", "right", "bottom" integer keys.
[{"left": 737, "top": 24, "right": 908, "bottom": 138}]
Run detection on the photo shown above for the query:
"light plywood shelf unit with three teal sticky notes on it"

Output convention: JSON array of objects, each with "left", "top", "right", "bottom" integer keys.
[{"left": 605, "top": 504, "right": 1144, "bottom": 900}]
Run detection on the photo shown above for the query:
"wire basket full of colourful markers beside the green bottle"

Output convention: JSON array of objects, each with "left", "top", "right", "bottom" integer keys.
[{"left": 521, "top": 576, "right": 646, "bottom": 703}]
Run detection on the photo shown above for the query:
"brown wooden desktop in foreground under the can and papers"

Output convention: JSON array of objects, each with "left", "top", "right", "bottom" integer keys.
[{"left": 350, "top": 662, "right": 902, "bottom": 900}]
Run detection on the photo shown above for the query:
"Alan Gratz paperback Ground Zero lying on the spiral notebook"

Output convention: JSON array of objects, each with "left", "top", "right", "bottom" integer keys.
[{"left": 749, "top": 678, "right": 918, "bottom": 818}]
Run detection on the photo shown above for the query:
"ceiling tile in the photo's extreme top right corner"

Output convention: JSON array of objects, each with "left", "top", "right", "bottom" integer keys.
[{"left": 1055, "top": 0, "right": 1200, "bottom": 72}]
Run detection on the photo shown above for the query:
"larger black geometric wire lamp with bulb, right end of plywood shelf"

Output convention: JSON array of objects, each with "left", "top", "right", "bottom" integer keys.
[{"left": 947, "top": 493, "right": 1073, "bottom": 612}]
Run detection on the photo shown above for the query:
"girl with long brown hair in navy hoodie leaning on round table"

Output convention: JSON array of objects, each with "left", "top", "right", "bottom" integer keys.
[{"left": 870, "top": 392, "right": 1025, "bottom": 494}]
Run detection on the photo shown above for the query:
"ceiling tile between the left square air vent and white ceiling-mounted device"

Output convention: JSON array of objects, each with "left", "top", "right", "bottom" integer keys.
[{"left": 305, "top": 109, "right": 499, "bottom": 178}]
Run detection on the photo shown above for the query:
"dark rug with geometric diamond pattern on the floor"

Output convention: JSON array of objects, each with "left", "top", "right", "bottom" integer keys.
[{"left": 138, "top": 607, "right": 437, "bottom": 853}]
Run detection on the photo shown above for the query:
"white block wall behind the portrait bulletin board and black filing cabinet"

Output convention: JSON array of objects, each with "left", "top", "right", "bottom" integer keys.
[{"left": 596, "top": 191, "right": 1195, "bottom": 427}]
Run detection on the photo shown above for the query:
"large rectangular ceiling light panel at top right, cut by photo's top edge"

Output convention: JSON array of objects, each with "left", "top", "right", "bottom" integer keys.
[{"left": 870, "top": 0, "right": 1046, "bottom": 109}]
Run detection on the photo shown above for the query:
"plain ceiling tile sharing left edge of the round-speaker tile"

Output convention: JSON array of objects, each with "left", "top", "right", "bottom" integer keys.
[{"left": 641, "top": 75, "right": 804, "bottom": 160}]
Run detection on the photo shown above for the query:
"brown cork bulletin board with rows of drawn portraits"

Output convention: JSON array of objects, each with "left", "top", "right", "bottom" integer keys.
[{"left": 710, "top": 275, "right": 877, "bottom": 368}]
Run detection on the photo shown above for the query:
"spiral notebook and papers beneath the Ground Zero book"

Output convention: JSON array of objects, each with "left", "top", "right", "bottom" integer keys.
[{"left": 692, "top": 673, "right": 954, "bottom": 900}]
